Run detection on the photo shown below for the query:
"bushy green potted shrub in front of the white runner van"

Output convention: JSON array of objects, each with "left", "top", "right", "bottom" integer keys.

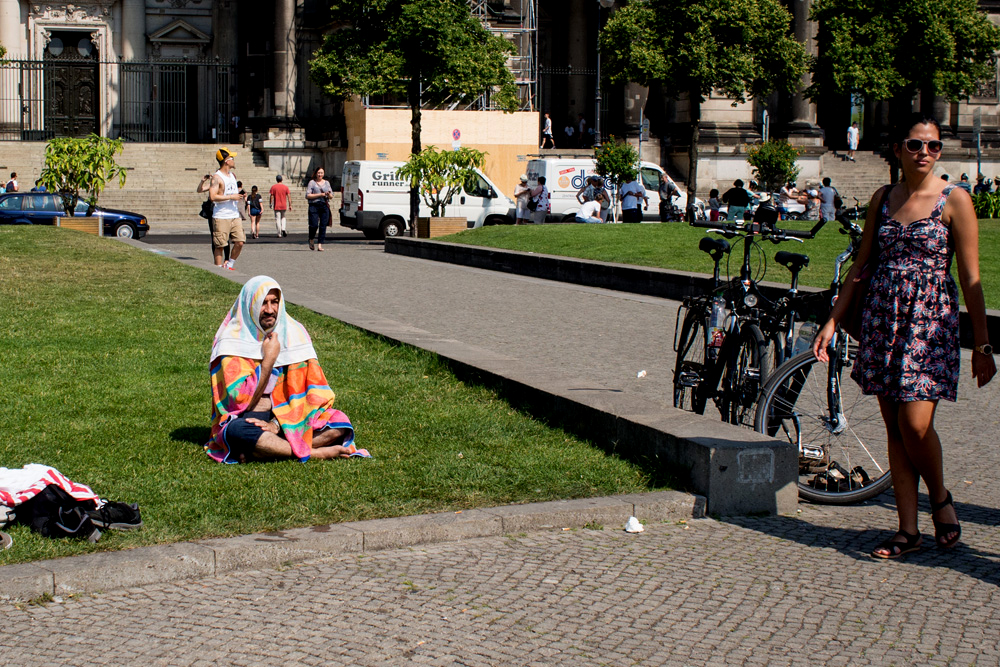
[{"left": 396, "top": 146, "right": 486, "bottom": 218}]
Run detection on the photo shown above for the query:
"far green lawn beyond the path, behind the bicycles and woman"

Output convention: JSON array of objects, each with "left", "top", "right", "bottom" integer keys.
[{"left": 437, "top": 220, "right": 1000, "bottom": 309}]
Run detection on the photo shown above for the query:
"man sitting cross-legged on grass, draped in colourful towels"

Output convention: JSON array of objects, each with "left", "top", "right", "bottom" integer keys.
[{"left": 205, "top": 276, "right": 369, "bottom": 463}]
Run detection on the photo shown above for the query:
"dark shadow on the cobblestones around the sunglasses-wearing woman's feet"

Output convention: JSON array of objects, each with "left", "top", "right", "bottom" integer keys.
[{"left": 720, "top": 493, "right": 1000, "bottom": 587}]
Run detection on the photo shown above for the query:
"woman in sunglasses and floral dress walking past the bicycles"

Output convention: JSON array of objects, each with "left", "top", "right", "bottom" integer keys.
[{"left": 813, "top": 113, "right": 996, "bottom": 558}]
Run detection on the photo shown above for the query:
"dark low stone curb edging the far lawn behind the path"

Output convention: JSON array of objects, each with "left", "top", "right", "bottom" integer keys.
[{"left": 385, "top": 237, "right": 1000, "bottom": 349}]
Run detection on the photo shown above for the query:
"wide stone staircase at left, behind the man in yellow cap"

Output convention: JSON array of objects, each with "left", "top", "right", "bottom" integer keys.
[{"left": 0, "top": 142, "right": 310, "bottom": 234}]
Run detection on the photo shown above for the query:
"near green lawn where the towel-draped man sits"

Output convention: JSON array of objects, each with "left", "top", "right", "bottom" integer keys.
[{"left": 0, "top": 227, "right": 656, "bottom": 564}]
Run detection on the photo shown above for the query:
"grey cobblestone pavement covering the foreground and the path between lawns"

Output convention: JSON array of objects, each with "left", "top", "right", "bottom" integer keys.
[{"left": 0, "top": 236, "right": 1000, "bottom": 665}]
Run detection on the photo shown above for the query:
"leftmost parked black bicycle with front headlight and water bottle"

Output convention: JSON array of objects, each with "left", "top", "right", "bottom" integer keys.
[{"left": 674, "top": 203, "right": 820, "bottom": 427}]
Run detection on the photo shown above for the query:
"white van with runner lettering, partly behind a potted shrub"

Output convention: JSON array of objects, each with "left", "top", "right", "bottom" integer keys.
[{"left": 340, "top": 160, "right": 514, "bottom": 239}]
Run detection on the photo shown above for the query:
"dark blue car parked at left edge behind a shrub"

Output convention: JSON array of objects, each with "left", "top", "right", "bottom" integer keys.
[{"left": 0, "top": 192, "right": 149, "bottom": 239}]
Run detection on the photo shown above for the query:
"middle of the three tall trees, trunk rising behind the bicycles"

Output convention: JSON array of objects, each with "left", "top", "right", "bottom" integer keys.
[{"left": 600, "top": 0, "right": 806, "bottom": 222}]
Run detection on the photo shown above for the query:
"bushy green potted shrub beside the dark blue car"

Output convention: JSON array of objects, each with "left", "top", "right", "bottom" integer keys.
[{"left": 40, "top": 134, "right": 126, "bottom": 215}]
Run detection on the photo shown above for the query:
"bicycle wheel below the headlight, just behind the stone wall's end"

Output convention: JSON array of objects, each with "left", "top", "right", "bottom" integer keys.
[{"left": 719, "top": 324, "right": 768, "bottom": 428}]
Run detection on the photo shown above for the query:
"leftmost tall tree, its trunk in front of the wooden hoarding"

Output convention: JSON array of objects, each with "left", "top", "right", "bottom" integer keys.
[{"left": 309, "top": 0, "right": 517, "bottom": 232}]
